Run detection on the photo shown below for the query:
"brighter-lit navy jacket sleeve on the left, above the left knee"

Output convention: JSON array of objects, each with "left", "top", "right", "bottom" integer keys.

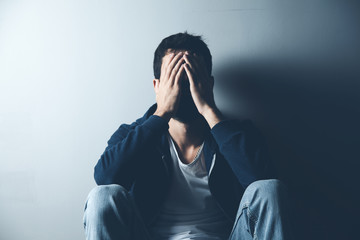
[{"left": 94, "top": 115, "right": 169, "bottom": 189}]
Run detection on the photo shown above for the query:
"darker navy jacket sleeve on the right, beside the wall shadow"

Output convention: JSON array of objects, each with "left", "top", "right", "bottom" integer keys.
[{"left": 211, "top": 119, "right": 276, "bottom": 188}]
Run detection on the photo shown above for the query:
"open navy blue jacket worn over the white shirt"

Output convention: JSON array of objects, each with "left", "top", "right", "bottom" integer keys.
[{"left": 94, "top": 103, "right": 274, "bottom": 227}]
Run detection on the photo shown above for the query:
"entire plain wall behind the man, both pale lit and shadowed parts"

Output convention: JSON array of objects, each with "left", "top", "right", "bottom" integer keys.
[{"left": 0, "top": 0, "right": 360, "bottom": 240}]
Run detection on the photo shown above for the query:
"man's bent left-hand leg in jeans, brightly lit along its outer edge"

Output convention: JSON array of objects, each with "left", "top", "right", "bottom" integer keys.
[{"left": 83, "top": 184, "right": 150, "bottom": 240}]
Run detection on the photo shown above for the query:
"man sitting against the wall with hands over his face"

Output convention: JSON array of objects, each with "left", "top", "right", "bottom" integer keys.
[{"left": 84, "top": 32, "right": 291, "bottom": 240}]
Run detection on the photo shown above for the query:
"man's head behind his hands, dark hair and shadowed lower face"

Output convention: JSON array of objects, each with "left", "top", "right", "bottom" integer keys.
[{"left": 153, "top": 31, "right": 212, "bottom": 123}]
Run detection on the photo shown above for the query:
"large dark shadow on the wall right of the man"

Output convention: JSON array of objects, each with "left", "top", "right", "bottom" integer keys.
[{"left": 214, "top": 60, "right": 360, "bottom": 239}]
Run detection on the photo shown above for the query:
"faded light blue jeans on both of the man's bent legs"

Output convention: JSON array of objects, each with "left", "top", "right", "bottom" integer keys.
[{"left": 83, "top": 179, "right": 293, "bottom": 240}]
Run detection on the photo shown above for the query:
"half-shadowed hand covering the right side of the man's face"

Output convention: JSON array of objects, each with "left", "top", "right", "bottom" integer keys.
[{"left": 184, "top": 52, "right": 224, "bottom": 128}]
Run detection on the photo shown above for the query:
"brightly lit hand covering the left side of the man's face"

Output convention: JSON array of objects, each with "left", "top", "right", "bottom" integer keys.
[{"left": 154, "top": 52, "right": 186, "bottom": 121}]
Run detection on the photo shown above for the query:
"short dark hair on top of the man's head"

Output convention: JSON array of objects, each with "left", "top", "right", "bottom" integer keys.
[{"left": 153, "top": 31, "right": 212, "bottom": 79}]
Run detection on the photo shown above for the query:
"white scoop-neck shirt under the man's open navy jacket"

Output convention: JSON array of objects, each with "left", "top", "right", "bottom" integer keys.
[{"left": 149, "top": 134, "right": 230, "bottom": 240}]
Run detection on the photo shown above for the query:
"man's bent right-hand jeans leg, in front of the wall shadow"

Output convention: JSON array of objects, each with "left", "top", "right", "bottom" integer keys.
[{"left": 229, "top": 179, "right": 293, "bottom": 240}]
